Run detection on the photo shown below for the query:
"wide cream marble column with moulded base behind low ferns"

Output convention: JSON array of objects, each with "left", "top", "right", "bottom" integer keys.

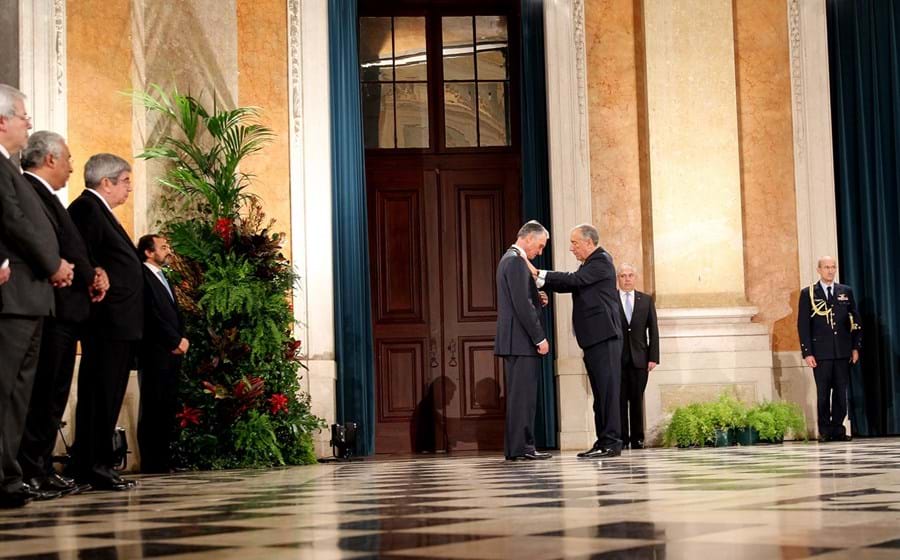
[{"left": 642, "top": 0, "right": 772, "bottom": 441}]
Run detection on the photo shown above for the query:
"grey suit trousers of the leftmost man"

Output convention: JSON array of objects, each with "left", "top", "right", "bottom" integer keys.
[{"left": 0, "top": 315, "right": 43, "bottom": 494}]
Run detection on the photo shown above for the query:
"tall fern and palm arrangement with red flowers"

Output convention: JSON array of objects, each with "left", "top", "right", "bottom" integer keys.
[{"left": 134, "top": 86, "right": 323, "bottom": 469}]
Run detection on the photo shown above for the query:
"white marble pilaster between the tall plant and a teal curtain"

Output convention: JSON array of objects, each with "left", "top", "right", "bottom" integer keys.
[{"left": 287, "top": 0, "right": 337, "bottom": 456}]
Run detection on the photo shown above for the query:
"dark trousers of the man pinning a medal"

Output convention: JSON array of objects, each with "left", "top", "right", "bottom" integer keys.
[{"left": 584, "top": 338, "right": 622, "bottom": 450}]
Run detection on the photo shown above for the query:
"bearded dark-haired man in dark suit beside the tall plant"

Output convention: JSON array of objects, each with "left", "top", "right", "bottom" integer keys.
[{"left": 137, "top": 234, "right": 189, "bottom": 473}]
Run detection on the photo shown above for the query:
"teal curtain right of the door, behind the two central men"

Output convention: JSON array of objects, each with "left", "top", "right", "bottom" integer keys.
[{"left": 521, "top": 0, "right": 559, "bottom": 448}]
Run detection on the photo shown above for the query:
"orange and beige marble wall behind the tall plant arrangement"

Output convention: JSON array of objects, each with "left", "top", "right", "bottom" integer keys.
[{"left": 66, "top": 0, "right": 291, "bottom": 468}]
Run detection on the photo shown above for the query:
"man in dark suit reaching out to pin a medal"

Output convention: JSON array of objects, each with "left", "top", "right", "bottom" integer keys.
[{"left": 531, "top": 224, "right": 622, "bottom": 458}]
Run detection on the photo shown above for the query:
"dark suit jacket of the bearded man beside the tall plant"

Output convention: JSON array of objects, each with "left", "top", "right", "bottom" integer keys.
[{"left": 141, "top": 265, "right": 184, "bottom": 367}]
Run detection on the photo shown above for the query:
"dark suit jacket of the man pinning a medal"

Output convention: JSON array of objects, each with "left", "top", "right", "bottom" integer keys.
[{"left": 543, "top": 247, "right": 622, "bottom": 349}]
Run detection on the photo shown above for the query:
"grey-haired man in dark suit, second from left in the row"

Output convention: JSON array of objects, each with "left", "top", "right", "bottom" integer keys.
[{"left": 19, "top": 131, "right": 109, "bottom": 494}]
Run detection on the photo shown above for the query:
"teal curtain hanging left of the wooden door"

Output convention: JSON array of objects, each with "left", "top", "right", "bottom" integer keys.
[{"left": 328, "top": 0, "right": 375, "bottom": 455}]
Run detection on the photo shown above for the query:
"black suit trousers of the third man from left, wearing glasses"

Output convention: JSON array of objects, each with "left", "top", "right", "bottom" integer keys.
[{"left": 71, "top": 333, "right": 138, "bottom": 482}]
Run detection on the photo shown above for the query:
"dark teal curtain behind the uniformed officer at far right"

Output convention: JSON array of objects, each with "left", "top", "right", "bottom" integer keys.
[{"left": 827, "top": 0, "right": 900, "bottom": 436}]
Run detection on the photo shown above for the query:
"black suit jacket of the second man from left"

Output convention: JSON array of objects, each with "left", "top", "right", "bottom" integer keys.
[{"left": 24, "top": 173, "right": 95, "bottom": 323}]
